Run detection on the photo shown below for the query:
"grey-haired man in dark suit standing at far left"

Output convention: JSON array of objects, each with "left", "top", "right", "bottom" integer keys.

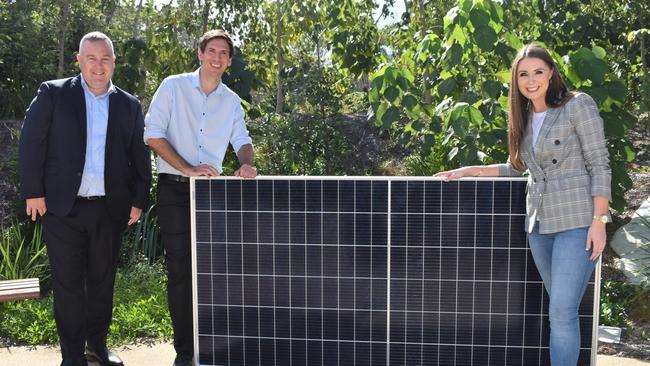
[{"left": 20, "top": 32, "right": 151, "bottom": 366}]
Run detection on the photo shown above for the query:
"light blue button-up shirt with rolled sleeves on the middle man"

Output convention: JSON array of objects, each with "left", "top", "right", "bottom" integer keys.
[{"left": 144, "top": 70, "right": 252, "bottom": 175}]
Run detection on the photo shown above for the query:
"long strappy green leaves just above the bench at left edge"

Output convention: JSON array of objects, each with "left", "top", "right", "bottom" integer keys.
[{"left": 0, "top": 221, "right": 50, "bottom": 282}]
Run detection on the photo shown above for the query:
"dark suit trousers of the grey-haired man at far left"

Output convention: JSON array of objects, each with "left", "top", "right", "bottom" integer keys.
[{"left": 42, "top": 199, "right": 126, "bottom": 359}]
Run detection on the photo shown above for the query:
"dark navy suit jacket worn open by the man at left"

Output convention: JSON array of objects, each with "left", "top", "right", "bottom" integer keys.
[{"left": 19, "top": 76, "right": 151, "bottom": 221}]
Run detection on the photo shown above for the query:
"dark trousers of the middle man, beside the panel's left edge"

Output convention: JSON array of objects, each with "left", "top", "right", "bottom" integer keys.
[{"left": 157, "top": 179, "right": 194, "bottom": 357}]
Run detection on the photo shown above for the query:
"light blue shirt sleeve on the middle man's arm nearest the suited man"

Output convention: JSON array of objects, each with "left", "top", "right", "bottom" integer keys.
[{"left": 143, "top": 79, "right": 174, "bottom": 144}]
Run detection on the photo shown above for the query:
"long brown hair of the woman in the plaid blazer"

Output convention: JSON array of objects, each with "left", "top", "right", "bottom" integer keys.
[{"left": 508, "top": 44, "right": 573, "bottom": 170}]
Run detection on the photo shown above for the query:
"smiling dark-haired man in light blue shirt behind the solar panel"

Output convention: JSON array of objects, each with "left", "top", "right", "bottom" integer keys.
[{"left": 144, "top": 30, "right": 257, "bottom": 366}]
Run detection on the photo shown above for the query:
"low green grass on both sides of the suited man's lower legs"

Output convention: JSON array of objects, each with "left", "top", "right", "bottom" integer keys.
[{"left": 0, "top": 262, "right": 172, "bottom": 346}]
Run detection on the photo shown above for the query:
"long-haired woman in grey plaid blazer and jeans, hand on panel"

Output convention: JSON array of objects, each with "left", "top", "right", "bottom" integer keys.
[{"left": 436, "top": 45, "right": 611, "bottom": 366}]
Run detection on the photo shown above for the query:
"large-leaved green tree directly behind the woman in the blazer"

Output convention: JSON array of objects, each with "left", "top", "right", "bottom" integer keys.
[{"left": 368, "top": 0, "right": 636, "bottom": 211}]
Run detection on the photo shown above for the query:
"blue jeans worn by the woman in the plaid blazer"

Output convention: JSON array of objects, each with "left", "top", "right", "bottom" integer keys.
[{"left": 528, "top": 225, "right": 596, "bottom": 366}]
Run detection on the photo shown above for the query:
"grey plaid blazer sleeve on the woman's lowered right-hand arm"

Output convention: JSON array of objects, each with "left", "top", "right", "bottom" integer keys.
[{"left": 569, "top": 93, "right": 612, "bottom": 200}]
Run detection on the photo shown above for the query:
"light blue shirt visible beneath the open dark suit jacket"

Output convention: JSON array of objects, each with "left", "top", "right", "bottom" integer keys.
[{"left": 78, "top": 76, "right": 115, "bottom": 196}]
